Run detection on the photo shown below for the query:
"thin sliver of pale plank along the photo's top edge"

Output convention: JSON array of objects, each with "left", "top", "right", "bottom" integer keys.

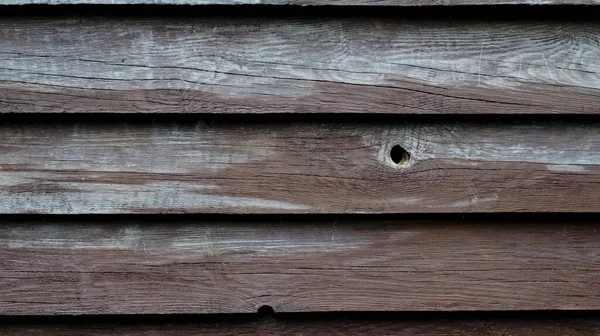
[{"left": 0, "top": 0, "right": 600, "bottom": 6}]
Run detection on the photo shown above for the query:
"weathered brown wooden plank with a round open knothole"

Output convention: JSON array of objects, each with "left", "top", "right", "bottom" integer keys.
[{"left": 0, "top": 118, "right": 600, "bottom": 214}]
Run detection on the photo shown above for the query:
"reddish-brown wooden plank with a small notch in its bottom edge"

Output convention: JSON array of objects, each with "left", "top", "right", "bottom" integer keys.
[{"left": 0, "top": 217, "right": 600, "bottom": 315}]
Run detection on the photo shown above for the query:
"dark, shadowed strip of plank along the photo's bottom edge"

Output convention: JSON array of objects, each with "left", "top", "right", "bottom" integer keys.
[{"left": 2, "top": 318, "right": 600, "bottom": 336}]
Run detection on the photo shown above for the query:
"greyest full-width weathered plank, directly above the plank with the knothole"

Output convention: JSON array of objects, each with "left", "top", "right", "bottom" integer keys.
[{"left": 0, "top": 17, "right": 600, "bottom": 114}]
